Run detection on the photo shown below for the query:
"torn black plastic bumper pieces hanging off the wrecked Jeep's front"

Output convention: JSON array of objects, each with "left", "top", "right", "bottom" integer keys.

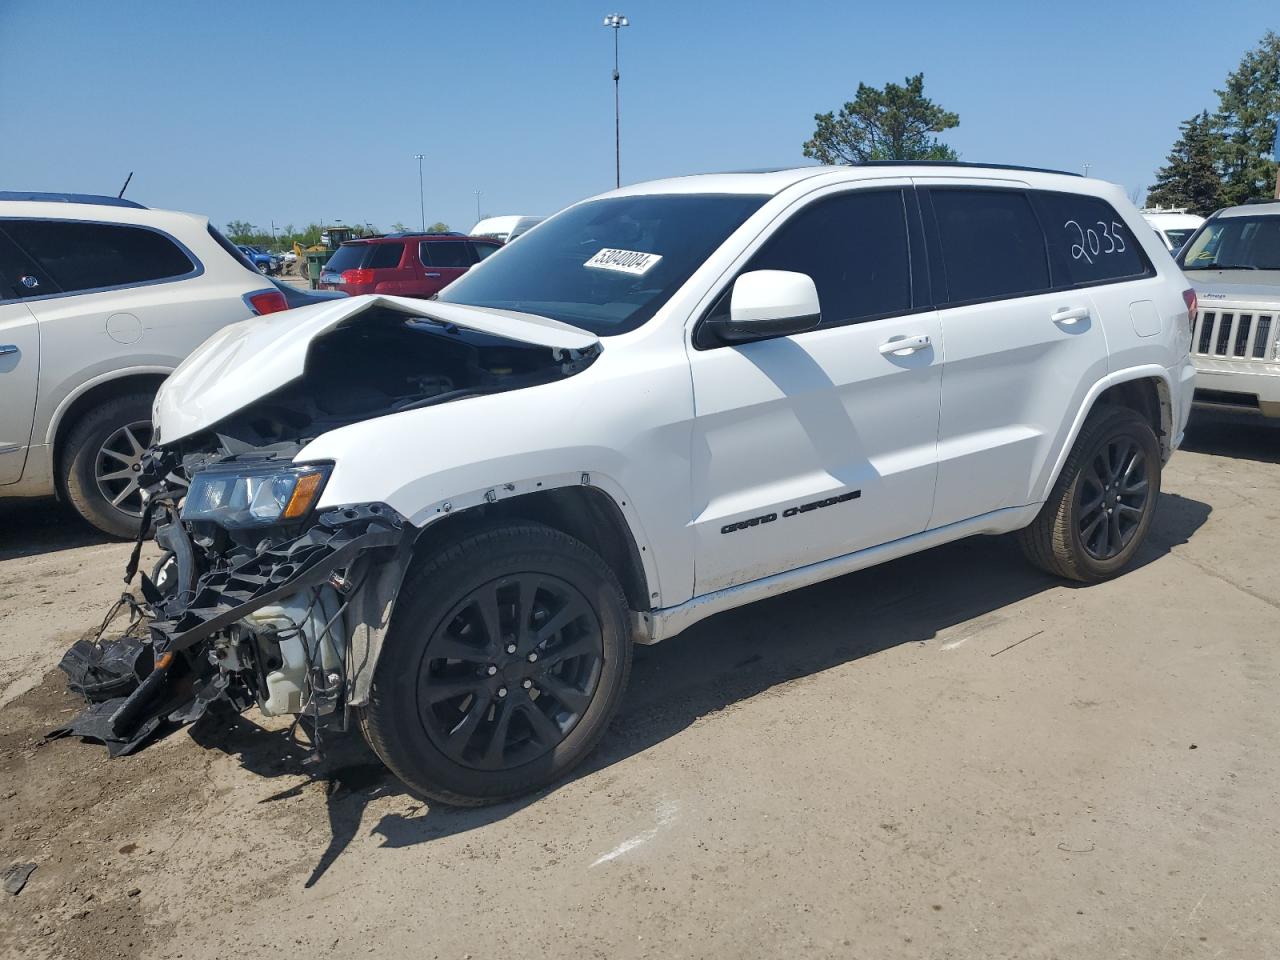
[{"left": 50, "top": 503, "right": 412, "bottom": 756}]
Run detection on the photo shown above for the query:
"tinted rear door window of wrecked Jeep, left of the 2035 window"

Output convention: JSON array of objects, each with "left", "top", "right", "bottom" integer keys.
[{"left": 929, "top": 187, "right": 1050, "bottom": 303}]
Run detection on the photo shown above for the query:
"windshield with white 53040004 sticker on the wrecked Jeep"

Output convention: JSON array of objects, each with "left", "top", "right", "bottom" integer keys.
[{"left": 439, "top": 193, "right": 767, "bottom": 337}]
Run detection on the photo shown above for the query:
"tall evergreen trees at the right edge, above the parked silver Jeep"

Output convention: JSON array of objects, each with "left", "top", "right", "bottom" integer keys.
[{"left": 1147, "top": 31, "right": 1280, "bottom": 216}]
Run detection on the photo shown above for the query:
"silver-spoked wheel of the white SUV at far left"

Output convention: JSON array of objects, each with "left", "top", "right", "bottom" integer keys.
[{"left": 61, "top": 393, "right": 152, "bottom": 540}]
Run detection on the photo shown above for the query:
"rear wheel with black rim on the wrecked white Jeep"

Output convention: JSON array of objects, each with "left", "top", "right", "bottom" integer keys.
[{"left": 1018, "top": 407, "right": 1161, "bottom": 582}]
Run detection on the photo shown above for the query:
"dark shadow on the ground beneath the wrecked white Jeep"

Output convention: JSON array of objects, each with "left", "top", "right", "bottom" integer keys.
[{"left": 192, "top": 493, "right": 1211, "bottom": 887}]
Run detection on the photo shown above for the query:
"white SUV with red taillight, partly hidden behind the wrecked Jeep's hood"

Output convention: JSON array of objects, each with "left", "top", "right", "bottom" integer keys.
[{"left": 0, "top": 192, "right": 288, "bottom": 536}]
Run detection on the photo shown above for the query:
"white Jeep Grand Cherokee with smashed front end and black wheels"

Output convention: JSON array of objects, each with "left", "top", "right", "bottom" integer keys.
[{"left": 77, "top": 164, "right": 1194, "bottom": 804}]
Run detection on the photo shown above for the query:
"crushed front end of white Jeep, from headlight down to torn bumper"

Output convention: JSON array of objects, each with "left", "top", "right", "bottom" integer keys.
[{"left": 54, "top": 451, "right": 413, "bottom": 756}]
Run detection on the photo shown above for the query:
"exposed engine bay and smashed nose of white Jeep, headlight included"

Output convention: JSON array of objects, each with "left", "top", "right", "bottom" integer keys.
[{"left": 54, "top": 308, "right": 595, "bottom": 756}]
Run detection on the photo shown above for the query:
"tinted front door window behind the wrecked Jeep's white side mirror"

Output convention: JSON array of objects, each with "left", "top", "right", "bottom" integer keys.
[{"left": 716, "top": 189, "right": 911, "bottom": 326}]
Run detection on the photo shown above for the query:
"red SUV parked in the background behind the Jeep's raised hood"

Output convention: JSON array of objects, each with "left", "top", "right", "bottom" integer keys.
[{"left": 320, "top": 233, "right": 502, "bottom": 297}]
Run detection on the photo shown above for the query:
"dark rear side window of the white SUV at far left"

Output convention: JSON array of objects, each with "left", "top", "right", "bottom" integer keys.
[{"left": 3, "top": 220, "right": 196, "bottom": 293}]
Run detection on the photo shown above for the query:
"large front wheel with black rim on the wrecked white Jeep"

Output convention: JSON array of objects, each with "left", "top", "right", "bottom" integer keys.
[{"left": 361, "top": 524, "right": 631, "bottom": 806}]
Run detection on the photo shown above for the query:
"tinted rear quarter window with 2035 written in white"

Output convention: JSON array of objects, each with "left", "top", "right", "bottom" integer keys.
[{"left": 1032, "top": 191, "right": 1151, "bottom": 287}]
